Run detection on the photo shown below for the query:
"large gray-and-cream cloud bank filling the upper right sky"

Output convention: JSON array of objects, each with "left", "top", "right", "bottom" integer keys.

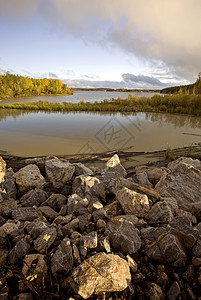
[{"left": 0, "top": 0, "right": 201, "bottom": 81}]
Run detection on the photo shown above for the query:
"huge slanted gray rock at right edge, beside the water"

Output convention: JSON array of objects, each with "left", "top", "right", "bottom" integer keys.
[{"left": 155, "top": 158, "right": 201, "bottom": 210}]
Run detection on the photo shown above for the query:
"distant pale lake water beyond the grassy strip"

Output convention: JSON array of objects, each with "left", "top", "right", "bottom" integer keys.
[{"left": 0, "top": 91, "right": 160, "bottom": 104}]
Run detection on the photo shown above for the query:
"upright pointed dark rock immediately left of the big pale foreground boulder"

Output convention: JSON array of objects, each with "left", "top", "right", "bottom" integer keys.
[{"left": 51, "top": 238, "right": 73, "bottom": 277}]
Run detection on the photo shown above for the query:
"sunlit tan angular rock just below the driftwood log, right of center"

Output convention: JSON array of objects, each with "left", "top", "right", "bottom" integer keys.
[{"left": 116, "top": 188, "right": 149, "bottom": 218}]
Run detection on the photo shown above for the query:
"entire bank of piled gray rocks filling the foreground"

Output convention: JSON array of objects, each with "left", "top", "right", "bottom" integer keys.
[{"left": 0, "top": 155, "right": 201, "bottom": 300}]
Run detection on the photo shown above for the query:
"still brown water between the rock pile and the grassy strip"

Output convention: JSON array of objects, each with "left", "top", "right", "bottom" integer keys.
[{"left": 0, "top": 110, "right": 201, "bottom": 156}]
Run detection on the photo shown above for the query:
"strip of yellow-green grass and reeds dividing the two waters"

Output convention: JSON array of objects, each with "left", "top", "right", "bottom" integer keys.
[{"left": 0, "top": 94, "right": 201, "bottom": 116}]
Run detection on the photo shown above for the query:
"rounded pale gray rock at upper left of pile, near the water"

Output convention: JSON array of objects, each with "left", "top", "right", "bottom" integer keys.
[{"left": 15, "top": 165, "right": 45, "bottom": 194}]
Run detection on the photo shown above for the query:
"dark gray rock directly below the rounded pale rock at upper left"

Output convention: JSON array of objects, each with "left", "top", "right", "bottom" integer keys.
[{"left": 20, "top": 188, "right": 48, "bottom": 206}]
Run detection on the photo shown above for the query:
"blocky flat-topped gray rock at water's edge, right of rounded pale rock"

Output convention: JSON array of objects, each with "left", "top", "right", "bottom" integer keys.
[{"left": 45, "top": 159, "right": 75, "bottom": 183}]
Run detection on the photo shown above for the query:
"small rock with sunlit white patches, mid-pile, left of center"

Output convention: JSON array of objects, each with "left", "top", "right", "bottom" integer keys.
[{"left": 67, "top": 194, "right": 89, "bottom": 216}]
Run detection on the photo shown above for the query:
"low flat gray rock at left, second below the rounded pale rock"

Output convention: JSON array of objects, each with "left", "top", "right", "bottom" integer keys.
[{"left": 12, "top": 207, "right": 43, "bottom": 221}]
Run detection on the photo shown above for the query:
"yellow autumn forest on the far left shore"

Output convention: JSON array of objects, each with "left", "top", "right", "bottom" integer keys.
[{"left": 0, "top": 73, "right": 73, "bottom": 98}]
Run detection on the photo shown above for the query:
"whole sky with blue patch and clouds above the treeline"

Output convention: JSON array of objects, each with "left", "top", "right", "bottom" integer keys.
[{"left": 0, "top": 0, "right": 201, "bottom": 89}]
